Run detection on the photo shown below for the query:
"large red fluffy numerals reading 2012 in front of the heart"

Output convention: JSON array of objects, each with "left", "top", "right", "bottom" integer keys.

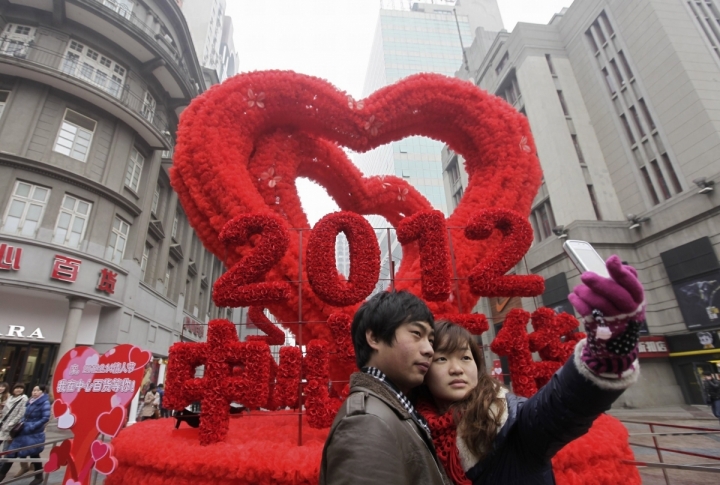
[{"left": 213, "top": 209, "right": 544, "bottom": 307}]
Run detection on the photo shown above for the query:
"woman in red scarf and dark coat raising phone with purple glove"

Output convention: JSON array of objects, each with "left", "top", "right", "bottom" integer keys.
[{"left": 417, "top": 256, "right": 645, "bottom": 485}]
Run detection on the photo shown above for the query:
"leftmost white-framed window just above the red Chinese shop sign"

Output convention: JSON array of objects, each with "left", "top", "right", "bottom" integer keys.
[{"left": 2, "top": 180, "right": 50, "bottom": 237}]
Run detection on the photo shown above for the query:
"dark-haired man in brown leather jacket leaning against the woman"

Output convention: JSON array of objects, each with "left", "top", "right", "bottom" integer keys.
[{"left": 320, "top": 292, "right": 451, "bottom": 485}]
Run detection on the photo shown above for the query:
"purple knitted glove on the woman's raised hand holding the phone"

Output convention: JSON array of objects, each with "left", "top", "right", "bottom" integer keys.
[{"left": 568, "top": 256, "right": 645, "bottom": 377}]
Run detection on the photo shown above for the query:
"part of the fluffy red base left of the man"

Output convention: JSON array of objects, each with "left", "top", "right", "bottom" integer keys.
[{"left": 105, "top": 411, "right": 329, "bottom": 485}]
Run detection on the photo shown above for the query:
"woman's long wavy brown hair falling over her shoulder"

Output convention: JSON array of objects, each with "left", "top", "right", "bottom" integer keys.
[{"left": 435, "top": 321, "right": 506, "bottom": 460}]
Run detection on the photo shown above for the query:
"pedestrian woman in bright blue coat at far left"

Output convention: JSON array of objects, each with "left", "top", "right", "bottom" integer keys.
[{"left": 0, "top": 386, "right": 50, "bottom": 485}]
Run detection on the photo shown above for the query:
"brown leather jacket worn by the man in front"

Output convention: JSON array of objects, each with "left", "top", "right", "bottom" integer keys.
[{"left": 320, "top": 372, "right": 452, "bottom": 485}]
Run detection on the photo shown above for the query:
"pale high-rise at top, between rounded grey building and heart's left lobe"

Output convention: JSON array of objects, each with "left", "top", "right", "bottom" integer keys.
[{"left": 181, "top": 0, "right": 238, "bottom": 84}]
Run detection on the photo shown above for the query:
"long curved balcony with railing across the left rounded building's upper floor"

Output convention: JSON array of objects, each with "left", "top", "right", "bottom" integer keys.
[{"left": 0, "top": 38, "right": 170, "bottom": 150}]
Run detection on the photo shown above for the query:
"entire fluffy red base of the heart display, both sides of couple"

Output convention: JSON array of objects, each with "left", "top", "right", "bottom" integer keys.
[{"left": 105, "top": 412, "right": 641, "bottom": 485}]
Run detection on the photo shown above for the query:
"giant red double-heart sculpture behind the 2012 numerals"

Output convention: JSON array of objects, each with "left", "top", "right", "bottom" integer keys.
[{"left": 172, "top": 71, "right": 541, "bottom": 342}]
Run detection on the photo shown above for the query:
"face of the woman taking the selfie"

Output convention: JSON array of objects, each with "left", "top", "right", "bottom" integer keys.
[{"left": 425, "top": 347, "right": 478, "bottom": 407}]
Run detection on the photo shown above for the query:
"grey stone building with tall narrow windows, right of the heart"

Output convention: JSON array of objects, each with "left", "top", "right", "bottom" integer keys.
[{"left": 442, "top": 0, "right": 720, "bottom": 407}]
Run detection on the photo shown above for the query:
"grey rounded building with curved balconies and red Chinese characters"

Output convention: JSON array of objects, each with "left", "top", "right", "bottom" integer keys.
[{"left": 0, "top": 0, "right": 227, "bottom": 388}]
